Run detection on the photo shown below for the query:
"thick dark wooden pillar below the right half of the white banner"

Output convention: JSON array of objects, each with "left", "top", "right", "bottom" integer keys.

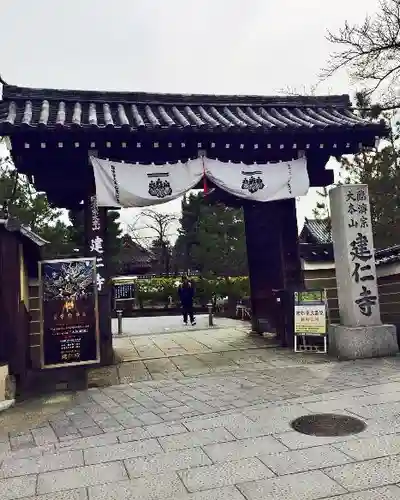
[{"left": 243, "top": 200, "right": 301, "bottom": 345}]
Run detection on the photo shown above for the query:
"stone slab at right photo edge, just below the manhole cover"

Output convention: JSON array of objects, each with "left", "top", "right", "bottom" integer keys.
[{"left": 334, "top": 434, "right": 400, "bottom": 460}]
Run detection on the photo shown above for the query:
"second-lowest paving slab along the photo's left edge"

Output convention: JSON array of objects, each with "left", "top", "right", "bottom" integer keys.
[{"left": 0, "top": 451, "right": 84, "bottom": 478}]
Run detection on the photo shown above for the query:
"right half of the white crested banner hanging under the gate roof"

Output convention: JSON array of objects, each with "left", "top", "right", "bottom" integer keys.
[{"left": 205, "top": 158, "right": 310, "bottom": 202}]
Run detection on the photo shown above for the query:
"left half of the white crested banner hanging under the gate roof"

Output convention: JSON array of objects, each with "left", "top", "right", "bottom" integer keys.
[{"left": 90, "top": 156, "right": 203, "bottom": 208}]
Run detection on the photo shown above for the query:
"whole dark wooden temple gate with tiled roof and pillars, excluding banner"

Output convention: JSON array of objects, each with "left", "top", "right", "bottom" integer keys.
[{"left": 0, "top": 82, "right": 387, "bottom": 364}]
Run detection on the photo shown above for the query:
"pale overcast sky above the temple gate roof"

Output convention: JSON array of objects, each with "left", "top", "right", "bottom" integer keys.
[{"left": 0, "top": 0, "right": 378, "bottom": 241}]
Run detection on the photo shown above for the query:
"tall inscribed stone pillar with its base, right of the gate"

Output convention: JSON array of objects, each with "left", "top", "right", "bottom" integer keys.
[{"left": 329, "top": 184, "right": 398, "bottom": 359}]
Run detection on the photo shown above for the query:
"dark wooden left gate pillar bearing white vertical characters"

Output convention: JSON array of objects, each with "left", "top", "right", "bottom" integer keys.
[{"left": 85, "top": 195, "right": 114, "bottom": 365}]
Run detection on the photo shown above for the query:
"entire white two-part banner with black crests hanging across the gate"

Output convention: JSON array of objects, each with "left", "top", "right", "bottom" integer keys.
[{"left": 90, "top": 157, "right": 310, "bottom": 208}]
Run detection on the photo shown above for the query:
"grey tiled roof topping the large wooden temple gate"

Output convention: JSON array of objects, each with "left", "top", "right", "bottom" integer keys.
[{"left": 0, "top": 85, "right": 385, "bottom": 135}]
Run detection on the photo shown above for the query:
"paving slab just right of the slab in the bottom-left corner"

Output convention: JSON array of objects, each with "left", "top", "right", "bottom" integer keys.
[{"left": 38, "top": 462, "right": 127, "bottom": 498}]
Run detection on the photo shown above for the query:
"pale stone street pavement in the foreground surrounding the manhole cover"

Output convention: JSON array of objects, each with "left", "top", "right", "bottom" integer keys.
[{"left": 0, "top": 349, "right": 400, "bottom": 500}]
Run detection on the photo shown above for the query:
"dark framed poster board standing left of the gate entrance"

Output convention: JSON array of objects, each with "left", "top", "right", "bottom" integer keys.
[{"left": 39, "top": 258, "right": 100, "bottom": 368}]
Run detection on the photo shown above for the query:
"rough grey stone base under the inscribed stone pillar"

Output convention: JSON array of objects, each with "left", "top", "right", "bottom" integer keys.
[{"left": 328, "top": 325, "right": 399, "bottom": 359}]
